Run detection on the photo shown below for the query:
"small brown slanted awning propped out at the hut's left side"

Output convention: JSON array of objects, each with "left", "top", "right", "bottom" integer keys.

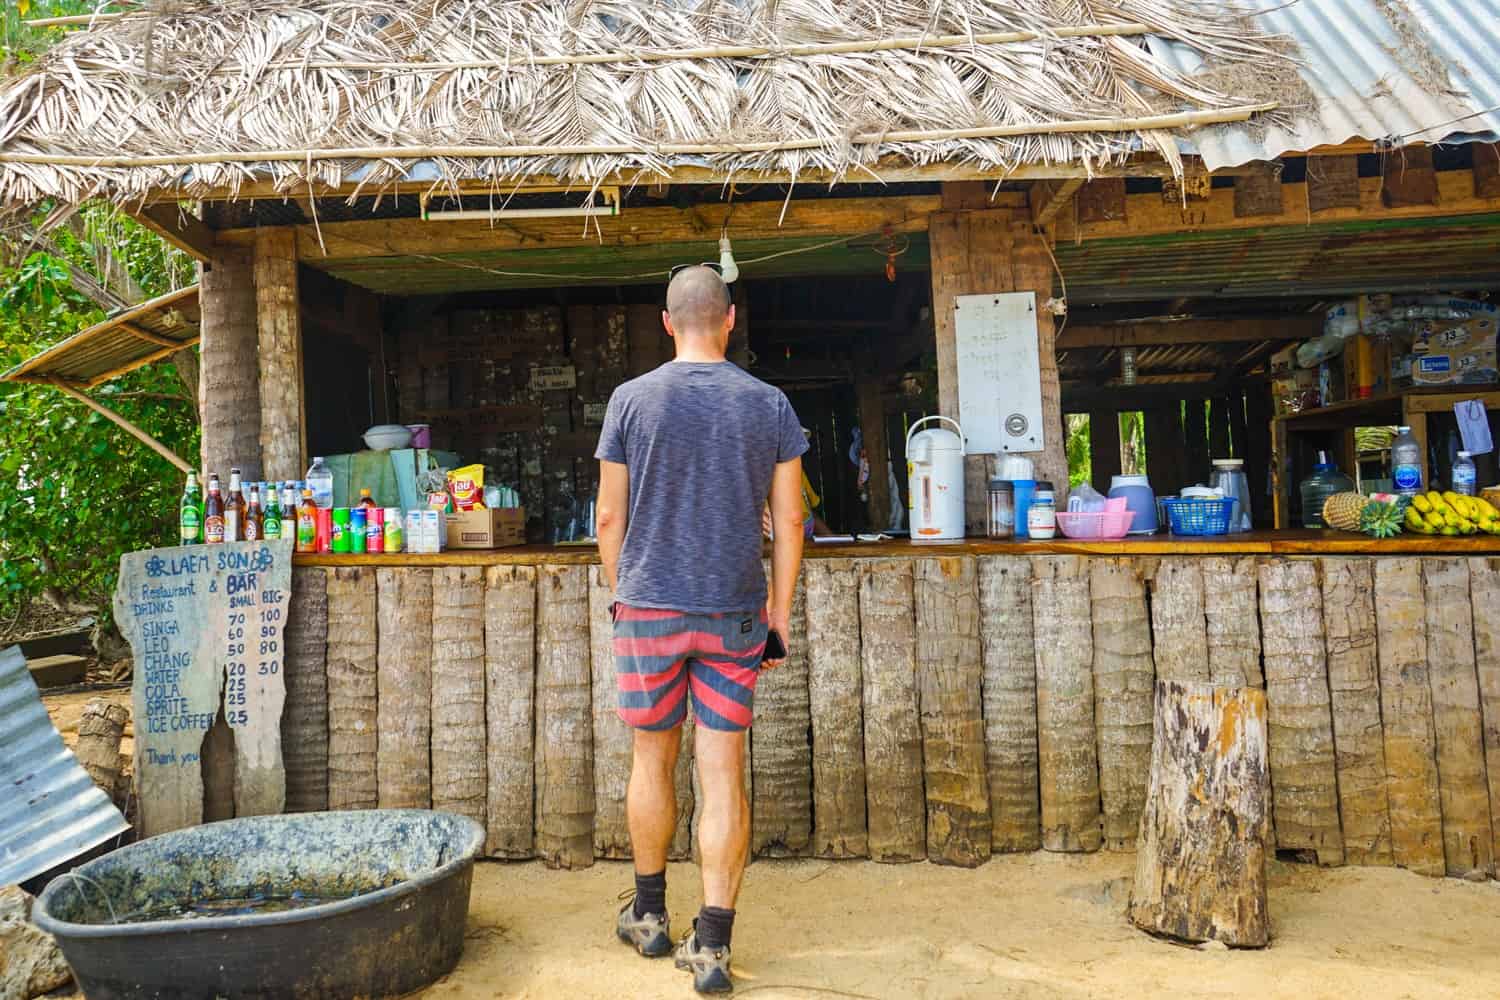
[{"left": 0, "top": 285, "right": 201, "bottom": 388}]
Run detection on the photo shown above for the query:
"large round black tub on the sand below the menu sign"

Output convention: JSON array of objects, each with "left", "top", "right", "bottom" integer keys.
[{"left": 33, "top": 810, "right": 485, "bottom": 1000}]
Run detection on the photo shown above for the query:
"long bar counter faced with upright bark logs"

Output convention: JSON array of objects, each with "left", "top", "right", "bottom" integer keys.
[{"left": 284, "top": 531, "right": 1500, "bottom": 877}]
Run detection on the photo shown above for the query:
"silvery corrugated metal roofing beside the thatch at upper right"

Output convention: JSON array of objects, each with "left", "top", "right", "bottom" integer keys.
[{"left": 1148, "top": 0, "right": 1500, "bottom": 169}]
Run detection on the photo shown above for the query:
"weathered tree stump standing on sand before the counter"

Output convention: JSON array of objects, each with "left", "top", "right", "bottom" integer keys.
[{"left": 1128, "top": 681, "right": 1271, "bottom": 948}]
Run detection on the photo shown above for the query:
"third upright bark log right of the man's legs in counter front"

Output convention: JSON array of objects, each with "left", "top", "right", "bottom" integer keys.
[{"left": 860, "top": 559, "right": 927, "bottom": 862}]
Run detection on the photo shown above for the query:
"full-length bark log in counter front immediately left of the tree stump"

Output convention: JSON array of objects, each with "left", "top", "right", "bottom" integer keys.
[{"left": 1089, "top": 559, "right": 1157, "bottom": 850}]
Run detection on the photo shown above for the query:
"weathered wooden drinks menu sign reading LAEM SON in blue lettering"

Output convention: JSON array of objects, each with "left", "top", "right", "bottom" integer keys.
[{"left": 114, "top": 538, "right": 291, "bottom": 837}]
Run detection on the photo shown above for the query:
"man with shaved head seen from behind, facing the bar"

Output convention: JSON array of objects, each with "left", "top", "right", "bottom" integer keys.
[{"left": 596, "top": 267, "right": 807, "bottom": 993}]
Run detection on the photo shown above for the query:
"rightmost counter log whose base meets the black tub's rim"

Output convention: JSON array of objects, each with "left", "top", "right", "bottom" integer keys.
[{"left": 432, "top": 567, "right": 489, "bottom": 825}]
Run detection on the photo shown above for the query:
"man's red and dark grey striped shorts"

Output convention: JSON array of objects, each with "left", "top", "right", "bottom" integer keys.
[{"left": 615, "top": 603, "right": 767, "bottom": 733}]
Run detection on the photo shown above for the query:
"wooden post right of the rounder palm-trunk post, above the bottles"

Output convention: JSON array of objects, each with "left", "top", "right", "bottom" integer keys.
[{"left": 253, "top": 226, "right": 308, "bottom": 480}]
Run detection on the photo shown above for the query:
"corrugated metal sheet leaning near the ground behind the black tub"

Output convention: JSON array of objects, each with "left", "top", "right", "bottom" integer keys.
[{"left": 0, "top": 646, "right": 131, "bottom": 886}]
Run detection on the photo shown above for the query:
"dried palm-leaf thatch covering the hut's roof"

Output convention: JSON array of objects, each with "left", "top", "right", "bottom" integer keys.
[{"left": 0, "top": 0, "right": 1296, "bottom": 204}]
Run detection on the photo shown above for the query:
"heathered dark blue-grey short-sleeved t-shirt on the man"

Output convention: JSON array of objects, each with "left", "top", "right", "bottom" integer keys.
[{"left": 594, "top": 361, "right": 807, "bottom": 615}]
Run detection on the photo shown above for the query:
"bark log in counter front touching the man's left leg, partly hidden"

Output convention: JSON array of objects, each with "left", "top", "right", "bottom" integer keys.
[{"left": 588, "top": 567, "right": 632, "bottom": 858}]
